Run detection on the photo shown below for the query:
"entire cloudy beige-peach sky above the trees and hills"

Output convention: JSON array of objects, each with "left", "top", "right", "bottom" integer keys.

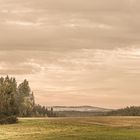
[{"left": 0, "top": 0, "right": 140, "bottom": 108}]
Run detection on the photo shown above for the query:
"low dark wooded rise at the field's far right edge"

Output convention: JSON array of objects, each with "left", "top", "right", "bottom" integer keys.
[{"left": 106, "top": 106, "right": 140, "bottom": 116}]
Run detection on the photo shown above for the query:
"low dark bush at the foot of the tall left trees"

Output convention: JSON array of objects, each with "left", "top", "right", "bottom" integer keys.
[{"left": 0, "top": 116, "right": 18, "bottom": 124}]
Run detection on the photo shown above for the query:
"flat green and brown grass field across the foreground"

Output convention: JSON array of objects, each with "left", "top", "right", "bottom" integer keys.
[{"left": 0, "top": 117, "right": 140, "bottom": 140}]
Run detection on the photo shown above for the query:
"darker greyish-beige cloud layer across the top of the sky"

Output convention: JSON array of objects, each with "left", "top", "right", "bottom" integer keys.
[{"left": 0, "top": 0, "right": 140, "bottom": 50}]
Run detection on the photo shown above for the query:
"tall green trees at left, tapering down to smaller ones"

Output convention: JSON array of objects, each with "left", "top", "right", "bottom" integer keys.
[{"left": 0, "top": 76, "right": 53, "bottom": 123}]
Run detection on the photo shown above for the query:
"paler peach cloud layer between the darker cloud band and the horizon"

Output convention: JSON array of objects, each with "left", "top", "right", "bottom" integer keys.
[{"left": 0, "top": 46, "right": 140, "bottom": 107}]
